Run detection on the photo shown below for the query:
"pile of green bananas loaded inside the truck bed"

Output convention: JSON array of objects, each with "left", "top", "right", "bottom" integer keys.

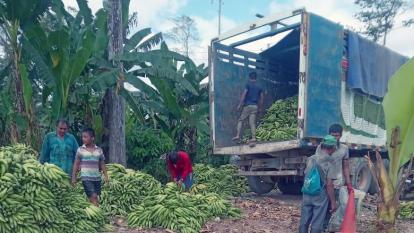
[{"left": 256, "top": 96, "right": 298, "bottom": 141}]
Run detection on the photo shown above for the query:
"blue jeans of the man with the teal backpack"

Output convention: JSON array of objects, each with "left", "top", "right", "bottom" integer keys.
[{"left": 299, "top": 189, "right": 329, "bottom": 233}]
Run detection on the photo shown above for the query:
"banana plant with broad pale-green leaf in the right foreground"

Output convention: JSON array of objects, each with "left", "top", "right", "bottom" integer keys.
[{"left": 369, "top": 59, "right": 414, "bottom": 233}]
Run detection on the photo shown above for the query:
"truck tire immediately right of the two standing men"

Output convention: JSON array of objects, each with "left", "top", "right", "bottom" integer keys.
[{"left": 350, "top": 158, "right": 372, "bottom": 192}]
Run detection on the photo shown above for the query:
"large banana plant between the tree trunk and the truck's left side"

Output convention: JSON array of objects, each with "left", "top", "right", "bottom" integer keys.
[{"left": 122, "top": 43, "right": 208, "bottom": 153}]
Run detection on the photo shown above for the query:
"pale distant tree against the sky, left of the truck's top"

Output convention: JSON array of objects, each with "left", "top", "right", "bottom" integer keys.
[{"left": 166, "top": 15, "right": 199, "bottom": 57}]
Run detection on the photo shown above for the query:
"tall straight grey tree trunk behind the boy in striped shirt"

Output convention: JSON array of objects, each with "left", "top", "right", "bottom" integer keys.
[{"left": 102, "top": 0, "right": 126, "bottom": 165}]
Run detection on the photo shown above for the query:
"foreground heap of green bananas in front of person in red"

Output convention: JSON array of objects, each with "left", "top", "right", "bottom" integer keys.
[{"left": 128, "top": 183, "right": 241, "bottom": 233}]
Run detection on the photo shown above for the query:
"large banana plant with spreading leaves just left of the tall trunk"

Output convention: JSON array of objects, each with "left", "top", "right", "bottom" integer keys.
[{"left": 24, "top": 0, "right": 107, "bottom": 125}]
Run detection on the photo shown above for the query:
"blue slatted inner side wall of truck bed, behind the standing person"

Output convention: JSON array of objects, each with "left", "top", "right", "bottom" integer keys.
[{"left": 210, "top": 43, "right": 299, "bottom": 149}]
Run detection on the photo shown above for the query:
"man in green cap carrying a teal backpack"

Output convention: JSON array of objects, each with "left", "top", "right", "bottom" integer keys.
[{"left": 299, "top": 135, "right": 337, "bottom": 233}]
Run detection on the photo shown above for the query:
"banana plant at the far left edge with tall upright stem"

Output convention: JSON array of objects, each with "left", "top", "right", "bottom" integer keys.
[{"left": 0, "top": 0, "right": 51, "bottom": 144}]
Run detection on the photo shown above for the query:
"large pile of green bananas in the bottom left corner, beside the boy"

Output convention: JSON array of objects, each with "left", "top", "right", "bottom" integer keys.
[{"left": 0, "top": 145, "right": 106, "bottom": 233}]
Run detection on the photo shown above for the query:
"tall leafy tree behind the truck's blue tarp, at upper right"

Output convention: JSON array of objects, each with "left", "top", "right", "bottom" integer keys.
[{"left": 355, "top": 0, "right": 412, "bottom": 45}]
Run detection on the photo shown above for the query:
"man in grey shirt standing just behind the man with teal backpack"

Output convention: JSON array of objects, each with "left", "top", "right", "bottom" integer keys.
[{"left": 316, "top": 124, "right": 353, "bottom": 232}]
